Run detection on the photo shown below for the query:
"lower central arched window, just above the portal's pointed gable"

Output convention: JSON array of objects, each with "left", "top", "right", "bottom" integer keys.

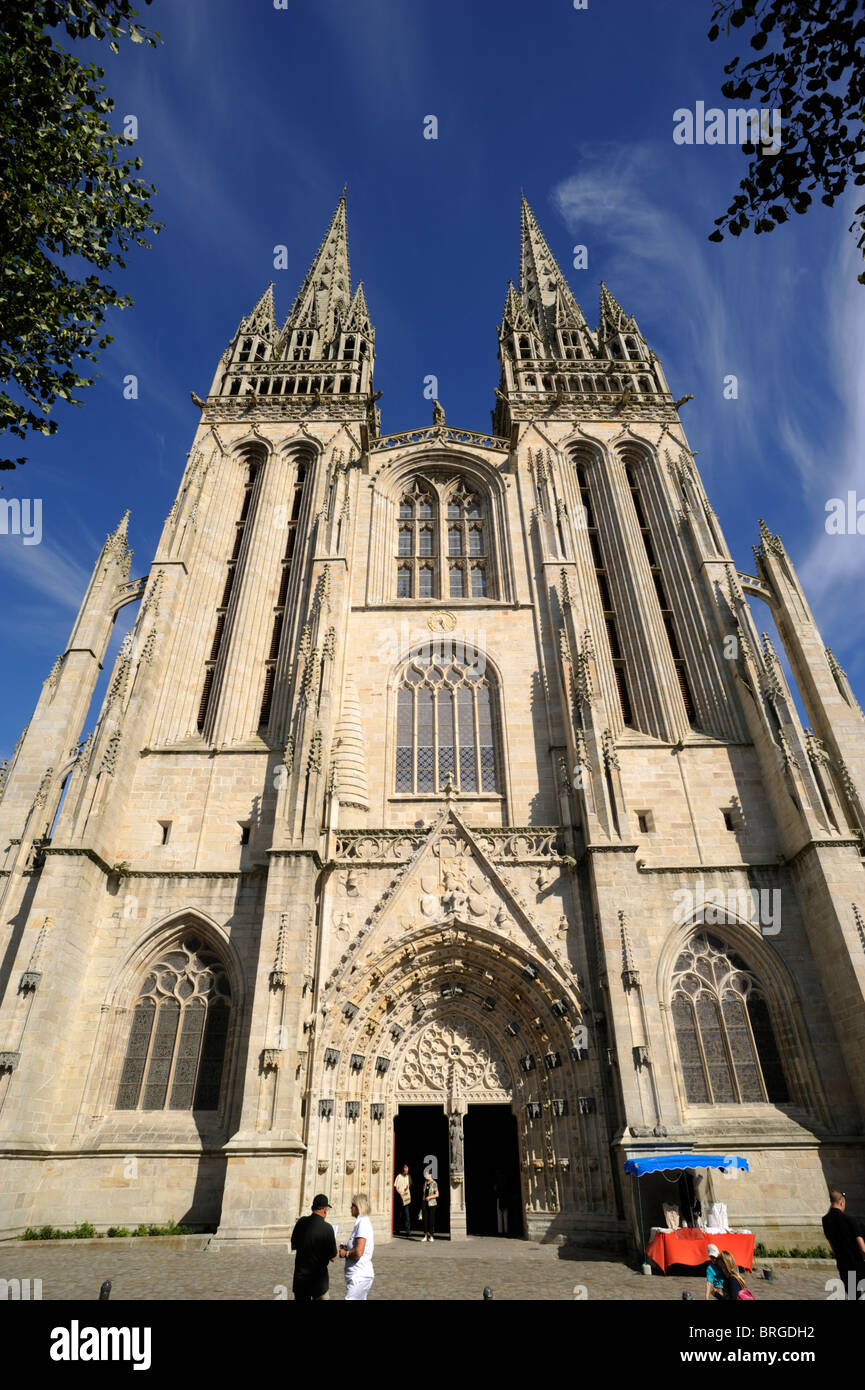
[{"left": 395, "top": 639, "right": 501, "bottom": 795}]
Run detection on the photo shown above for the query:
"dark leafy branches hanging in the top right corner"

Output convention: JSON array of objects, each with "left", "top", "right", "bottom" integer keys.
[{"left": 708, "top": 0, "right": 865, "bottom": 284}]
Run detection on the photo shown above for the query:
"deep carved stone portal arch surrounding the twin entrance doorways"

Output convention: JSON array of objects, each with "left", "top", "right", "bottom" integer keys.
[{"left": 305, "top": 913, "right": 612, "bottom": 1234}]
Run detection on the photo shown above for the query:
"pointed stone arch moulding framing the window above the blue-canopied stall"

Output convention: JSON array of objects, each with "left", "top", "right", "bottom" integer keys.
[{"left": 656, "top": 906, "right": 829, "bottom": 1123}]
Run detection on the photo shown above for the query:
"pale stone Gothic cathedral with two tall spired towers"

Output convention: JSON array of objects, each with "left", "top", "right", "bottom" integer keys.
[{"left": 0, "top": 196, "right": 865, "bottom": 1250}]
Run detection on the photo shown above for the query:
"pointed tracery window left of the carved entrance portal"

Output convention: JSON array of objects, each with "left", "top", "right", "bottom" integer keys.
[{"left": 117, "top": 931, "right": 231, "bottom": 1111}]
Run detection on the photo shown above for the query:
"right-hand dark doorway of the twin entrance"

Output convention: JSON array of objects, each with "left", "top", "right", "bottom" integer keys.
[{"left": 463, "top": 1105, "right": 523, "bottom": 1236}]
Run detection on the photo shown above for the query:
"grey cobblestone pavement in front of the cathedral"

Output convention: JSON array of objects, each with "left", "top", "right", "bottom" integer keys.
[{"left": 0, "top": 1238, "right": 834, "bottom": 1301}]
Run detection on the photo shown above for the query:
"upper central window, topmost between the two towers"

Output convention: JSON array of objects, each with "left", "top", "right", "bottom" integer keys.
[{"left": 396, "top": 475, "right": 492, "bottom": 599}]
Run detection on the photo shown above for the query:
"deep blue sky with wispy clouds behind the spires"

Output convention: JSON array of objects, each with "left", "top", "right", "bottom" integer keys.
[{"left": 0, "top": 0, "right": 865, "bottom": 758}]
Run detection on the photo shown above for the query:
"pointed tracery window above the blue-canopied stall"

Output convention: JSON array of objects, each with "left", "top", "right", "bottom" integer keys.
[{"left": 672, "top": 935, "right": 790, "bottom": 1105}]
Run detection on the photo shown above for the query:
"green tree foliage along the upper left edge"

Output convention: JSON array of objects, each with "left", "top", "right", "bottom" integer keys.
[{"left": 0, "top": 0, "right": 160, "bottom": 468}]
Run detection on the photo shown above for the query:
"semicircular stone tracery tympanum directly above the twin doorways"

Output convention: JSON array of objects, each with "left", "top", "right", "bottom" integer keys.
[{"left": 398, "top": 1016, "right": 512, "bottom": 1098}]
